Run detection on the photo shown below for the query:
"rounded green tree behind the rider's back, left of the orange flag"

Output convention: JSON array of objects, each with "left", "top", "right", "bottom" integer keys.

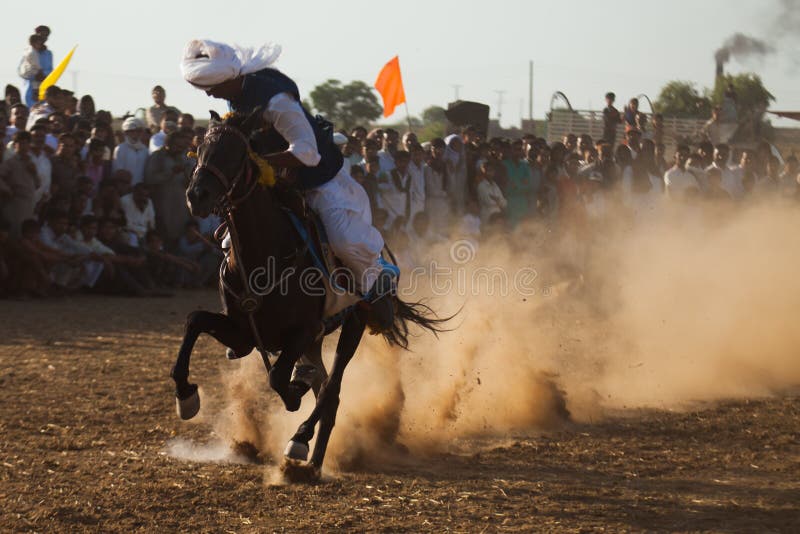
[{"left": 309, "top": 80, "right": 383, "bottom": 131}]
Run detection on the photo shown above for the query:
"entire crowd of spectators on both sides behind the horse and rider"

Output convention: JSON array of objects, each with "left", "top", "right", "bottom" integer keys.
[{"left": 0, "top": 26, "right": 799, "bottom": 297}]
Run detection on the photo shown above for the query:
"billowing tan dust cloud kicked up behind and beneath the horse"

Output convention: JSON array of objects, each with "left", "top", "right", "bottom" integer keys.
[{"left": 189, "top": 199, "right": 800, "bottom": 470}]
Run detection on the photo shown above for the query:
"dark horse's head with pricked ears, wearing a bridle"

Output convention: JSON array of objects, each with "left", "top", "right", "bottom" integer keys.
[{"left": 186, "top": 107, "right": 263, "bottom": 217}]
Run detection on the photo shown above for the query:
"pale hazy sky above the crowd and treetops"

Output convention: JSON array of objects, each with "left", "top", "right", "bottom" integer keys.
[{"left": 0, "top": 0, "right": 800, "bottom": 126}]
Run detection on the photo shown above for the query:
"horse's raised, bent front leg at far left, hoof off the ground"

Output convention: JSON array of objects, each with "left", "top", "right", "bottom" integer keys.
[{"left": 170, "top": 311, "right": 253, "bottom": 419}]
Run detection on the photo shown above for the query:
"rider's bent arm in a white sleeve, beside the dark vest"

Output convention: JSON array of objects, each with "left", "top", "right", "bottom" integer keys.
[{"left": 264, "top": 93, "right": 321, "bottom": 167}]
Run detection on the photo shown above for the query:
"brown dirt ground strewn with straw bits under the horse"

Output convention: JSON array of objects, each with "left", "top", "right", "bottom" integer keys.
[{"left": 0, "top": 292, "right": 800, "bottom": 532}]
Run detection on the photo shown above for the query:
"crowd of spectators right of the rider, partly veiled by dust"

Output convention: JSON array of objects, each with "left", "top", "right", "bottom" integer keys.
[{"left": 350, "top": 93, "right": 800, "bottom": 274}]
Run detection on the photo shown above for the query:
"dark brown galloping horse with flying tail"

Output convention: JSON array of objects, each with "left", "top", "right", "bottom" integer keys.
[{"left": 171, "top": 108, "right": 449, "bottom": 478}]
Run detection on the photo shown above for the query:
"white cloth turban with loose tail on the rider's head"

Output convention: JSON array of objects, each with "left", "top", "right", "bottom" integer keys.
[{"left": 181, "top": 39, "right": 281, "bottom": 89}]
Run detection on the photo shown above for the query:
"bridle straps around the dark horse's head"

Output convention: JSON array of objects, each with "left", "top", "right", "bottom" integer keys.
[{"left": 192, "top": 124, "right": 258, "bottom": 213}]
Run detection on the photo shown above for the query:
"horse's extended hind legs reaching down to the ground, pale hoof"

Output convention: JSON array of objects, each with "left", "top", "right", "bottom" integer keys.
[{"left": 284, "top": 313, "right": 365, "bottom": 470}]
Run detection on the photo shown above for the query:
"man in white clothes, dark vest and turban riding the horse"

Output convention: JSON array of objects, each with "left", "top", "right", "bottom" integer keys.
[{"left": 181, "top": 40, "right": 396, "bottom": 329}]
